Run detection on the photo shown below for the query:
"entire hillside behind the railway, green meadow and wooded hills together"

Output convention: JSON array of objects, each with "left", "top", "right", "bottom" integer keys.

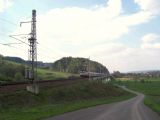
[{"left": 0, "top": 56, "right": 109, "bottom": 83}]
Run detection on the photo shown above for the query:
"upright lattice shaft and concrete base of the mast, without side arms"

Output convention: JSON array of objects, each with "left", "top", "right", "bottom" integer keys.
[{"left": 26, "top": 10, "right": 39, "bottom": 94}]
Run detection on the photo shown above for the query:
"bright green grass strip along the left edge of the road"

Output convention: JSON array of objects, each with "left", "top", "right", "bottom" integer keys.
[{"left": 0, "top": 95, "right": 133, "bottom": 120}]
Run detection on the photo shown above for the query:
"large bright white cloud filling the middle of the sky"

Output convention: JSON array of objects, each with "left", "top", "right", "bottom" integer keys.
[{"left": 10, "top": 0, "right": 125, "bottom": 61}]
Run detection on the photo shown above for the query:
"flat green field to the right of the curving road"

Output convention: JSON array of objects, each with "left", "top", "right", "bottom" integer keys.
[{"left": 115, "top": 78, "right": 160, "bottom": 114}]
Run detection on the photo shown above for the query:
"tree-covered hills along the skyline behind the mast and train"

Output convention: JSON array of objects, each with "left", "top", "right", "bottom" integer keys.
[{"left": 4, "top": 56, "right": 109, "bottom": 74}]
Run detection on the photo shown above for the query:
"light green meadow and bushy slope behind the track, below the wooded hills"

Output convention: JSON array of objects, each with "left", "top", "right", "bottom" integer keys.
[{"left": 0, "top": 55, "right": 77, "bottom": 84}]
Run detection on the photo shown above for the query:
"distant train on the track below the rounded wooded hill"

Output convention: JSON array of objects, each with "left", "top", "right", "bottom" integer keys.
[{"left": 80, "top": 71, "right": 108, "bottom": 78}]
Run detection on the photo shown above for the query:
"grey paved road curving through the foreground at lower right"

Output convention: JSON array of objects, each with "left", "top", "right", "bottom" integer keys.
[{"left": 47, "top": 87, "right": 160, "bottom": 120}]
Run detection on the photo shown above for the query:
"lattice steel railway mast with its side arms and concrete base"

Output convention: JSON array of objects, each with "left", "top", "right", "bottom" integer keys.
[{"left": 9, "top": 10, "right": 39, "bottom": 94}]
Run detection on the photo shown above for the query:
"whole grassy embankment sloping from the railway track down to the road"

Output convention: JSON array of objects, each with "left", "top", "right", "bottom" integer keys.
[{"left": 0, "top": 82, "right": 134, "bottom": 120}]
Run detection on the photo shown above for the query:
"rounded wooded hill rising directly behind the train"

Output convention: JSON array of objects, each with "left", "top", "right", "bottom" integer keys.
[{"left": 52, "top": 57, "right": 109, "bottom": 74}]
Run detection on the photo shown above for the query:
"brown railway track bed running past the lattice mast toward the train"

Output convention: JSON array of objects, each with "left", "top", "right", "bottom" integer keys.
[{"left": 0, "top": 78, "right": 88, "bottom": 93}]
